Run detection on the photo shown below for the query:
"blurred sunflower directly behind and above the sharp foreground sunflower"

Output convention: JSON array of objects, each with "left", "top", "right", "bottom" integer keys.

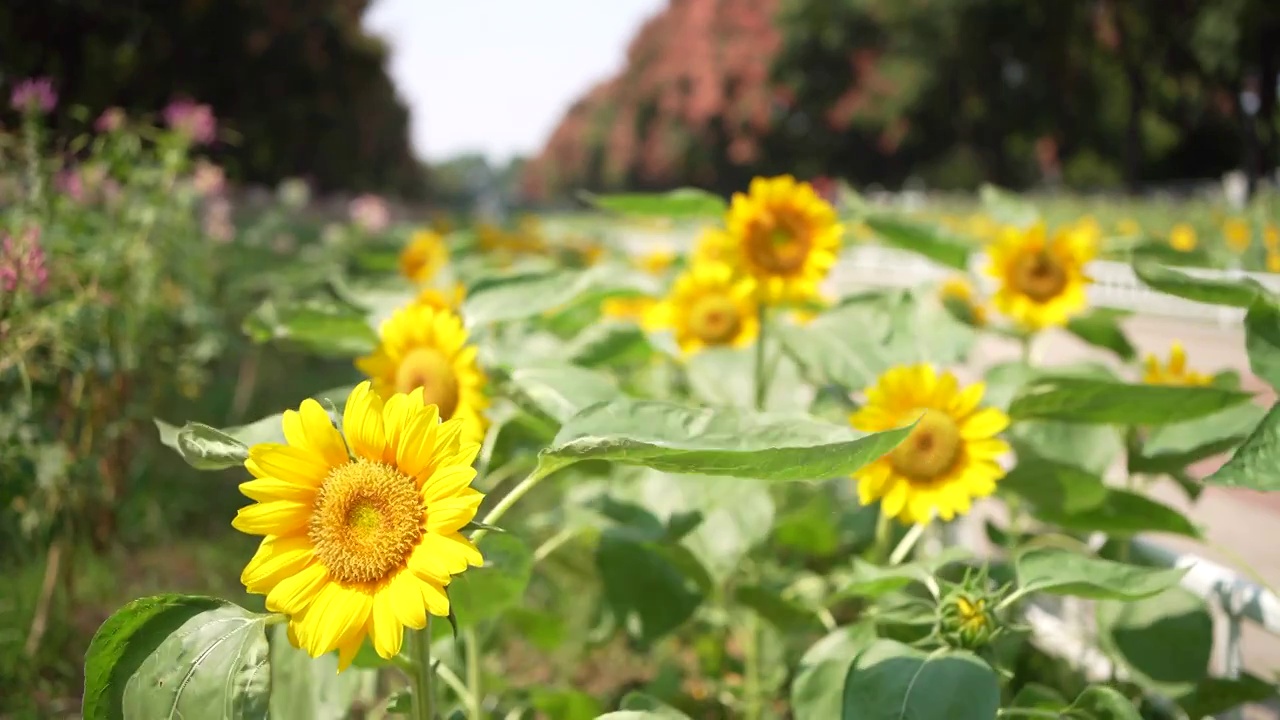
[{"left": 356, "top": 302, "right": 489, "bottom": 438}]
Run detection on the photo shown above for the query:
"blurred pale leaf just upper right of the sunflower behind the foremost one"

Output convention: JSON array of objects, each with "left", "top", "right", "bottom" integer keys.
[{"left": 462, "top": 264, "right": 645, "bottom": 327}]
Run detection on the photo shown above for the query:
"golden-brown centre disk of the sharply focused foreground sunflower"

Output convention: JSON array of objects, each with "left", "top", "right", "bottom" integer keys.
[{"left": 307, "top": 459, "right": 425, "bottom": 583}]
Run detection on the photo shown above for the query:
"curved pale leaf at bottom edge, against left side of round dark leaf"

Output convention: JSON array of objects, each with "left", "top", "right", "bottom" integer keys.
[{"left": 791, "top": 623, "right": 876, "bottom": 720}]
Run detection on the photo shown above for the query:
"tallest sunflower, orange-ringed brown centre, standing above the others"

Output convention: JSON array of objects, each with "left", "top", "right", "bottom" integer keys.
[{"left": 727, "top": 176, "right": 844, "bottom": 302}]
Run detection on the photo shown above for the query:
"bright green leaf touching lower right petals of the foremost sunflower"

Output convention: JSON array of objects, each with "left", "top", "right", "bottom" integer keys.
[{"left": 433, "top": 533, "right": 534, "bottom": 627}]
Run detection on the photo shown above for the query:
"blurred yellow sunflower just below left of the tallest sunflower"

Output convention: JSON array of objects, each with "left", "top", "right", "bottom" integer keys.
[{"left": 645, "top": 263, "right": 760, "bottom": 354}]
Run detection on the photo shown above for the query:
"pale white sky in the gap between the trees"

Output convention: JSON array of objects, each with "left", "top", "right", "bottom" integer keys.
[{"left": 365, "top": 0, "right": 666, "bottom": 161}]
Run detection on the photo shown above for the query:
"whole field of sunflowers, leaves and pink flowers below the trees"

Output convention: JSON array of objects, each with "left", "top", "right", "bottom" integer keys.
[{"left": 0, "top": 98, "right": 1280, "bottom": 720}]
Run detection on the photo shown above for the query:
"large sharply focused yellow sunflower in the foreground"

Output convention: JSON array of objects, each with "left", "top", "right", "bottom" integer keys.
[{"left": 232, "top": 382, "right": 484, "bottom": 670}]
